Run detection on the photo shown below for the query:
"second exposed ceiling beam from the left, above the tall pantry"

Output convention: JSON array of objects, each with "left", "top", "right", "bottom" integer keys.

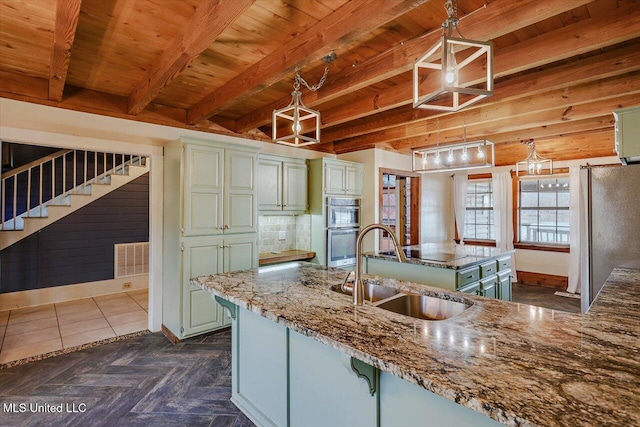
[{"left": 127, "top": 0, "right": 255, "bottom": 114}]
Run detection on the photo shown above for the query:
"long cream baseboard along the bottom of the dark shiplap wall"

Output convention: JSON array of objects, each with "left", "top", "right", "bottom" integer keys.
[{"left": 0, "top": 274, "right": 149, "bottom": 311}]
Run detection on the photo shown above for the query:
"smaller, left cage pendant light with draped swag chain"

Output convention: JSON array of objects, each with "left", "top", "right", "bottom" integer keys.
[{"left": 271, "top": 52, "right": 336, "bottom": 147}]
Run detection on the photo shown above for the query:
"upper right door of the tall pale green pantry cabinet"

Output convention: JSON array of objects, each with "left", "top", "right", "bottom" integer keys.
[{"left": 223, "top": 150, "right": 258, "bottom": 233}]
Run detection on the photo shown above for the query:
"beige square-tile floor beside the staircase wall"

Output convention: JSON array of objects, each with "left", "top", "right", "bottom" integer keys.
[{"left": 0, "top": 289, "right": 149, "bottom": 364}]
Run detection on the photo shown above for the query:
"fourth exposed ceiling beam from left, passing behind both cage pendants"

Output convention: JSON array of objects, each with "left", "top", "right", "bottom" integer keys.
[{"left": 236, "top": 0, "right": 592, "bottom": 132}]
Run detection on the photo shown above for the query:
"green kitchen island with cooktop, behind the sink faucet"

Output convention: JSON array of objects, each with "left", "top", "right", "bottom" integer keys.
[{"left": 363, "top": 243, "right": 514, "bottom": 301}]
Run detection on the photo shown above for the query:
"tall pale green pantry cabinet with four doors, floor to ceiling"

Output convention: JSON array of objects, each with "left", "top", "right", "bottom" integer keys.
[{"left": 162, "top": 138, "right": 258, "bottom": 339}]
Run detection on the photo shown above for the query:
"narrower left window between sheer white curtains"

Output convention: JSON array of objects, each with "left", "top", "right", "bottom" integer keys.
[{"left": 464, "top": 180, "right": 495, "bottom": 240}]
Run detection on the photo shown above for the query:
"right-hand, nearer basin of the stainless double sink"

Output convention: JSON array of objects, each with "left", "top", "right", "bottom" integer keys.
[{"left": 377, "top": 294, "right": 469, "bottom": 320}]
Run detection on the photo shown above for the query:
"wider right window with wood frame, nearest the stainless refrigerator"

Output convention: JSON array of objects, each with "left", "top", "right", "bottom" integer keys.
[{"left": 518, "top": 177, "right": 569, "bottom": 245}]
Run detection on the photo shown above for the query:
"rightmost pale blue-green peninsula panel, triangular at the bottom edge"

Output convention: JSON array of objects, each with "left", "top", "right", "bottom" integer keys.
[{"left": 378, "top": 372, "right": 502, "bottom": 427}]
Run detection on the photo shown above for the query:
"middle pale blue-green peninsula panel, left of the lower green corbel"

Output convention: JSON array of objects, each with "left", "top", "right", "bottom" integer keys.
[{"left": 289, "top": 331, "right": 377, "bottom": 427}]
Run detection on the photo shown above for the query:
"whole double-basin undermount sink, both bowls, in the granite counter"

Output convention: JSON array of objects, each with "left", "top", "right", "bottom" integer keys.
[{"left": 331, "top": 283, "right": 469, "bottom": 320}]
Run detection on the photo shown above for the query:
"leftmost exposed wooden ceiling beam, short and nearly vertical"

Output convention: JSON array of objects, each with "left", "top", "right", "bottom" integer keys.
[{"left": 49, "top": 0, "right": 82, "bottom": 101}]
